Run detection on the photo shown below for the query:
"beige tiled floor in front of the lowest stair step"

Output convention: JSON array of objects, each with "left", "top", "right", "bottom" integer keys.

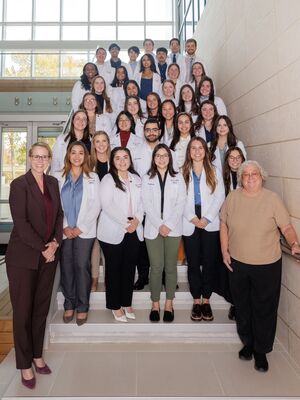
[{"left": 0, "top": 343, "right": 300, "bottom": 399}]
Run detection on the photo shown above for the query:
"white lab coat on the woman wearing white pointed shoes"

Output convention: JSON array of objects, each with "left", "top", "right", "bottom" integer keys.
[{"left": 97, "top": 173, "right": 144, "bottom": 244}]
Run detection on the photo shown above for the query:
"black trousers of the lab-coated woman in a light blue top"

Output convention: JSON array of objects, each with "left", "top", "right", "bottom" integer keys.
[{"left": 183, "top": 227, "right": 220, "bottom": 299}]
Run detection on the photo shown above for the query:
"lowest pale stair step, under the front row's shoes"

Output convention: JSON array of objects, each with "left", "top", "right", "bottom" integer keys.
[{"left": 49, "top": 309, "right": 237, "bottom": 343}]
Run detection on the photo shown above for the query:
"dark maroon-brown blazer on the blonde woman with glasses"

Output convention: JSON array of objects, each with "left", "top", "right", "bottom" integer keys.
[{"left": 6, "top": 170, "right": 63, "bottom": 269}]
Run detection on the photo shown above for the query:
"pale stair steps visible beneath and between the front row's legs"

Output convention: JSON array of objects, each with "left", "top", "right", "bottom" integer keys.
[{"left": 49, "top": 266, "right": 237, "bottom": 343}]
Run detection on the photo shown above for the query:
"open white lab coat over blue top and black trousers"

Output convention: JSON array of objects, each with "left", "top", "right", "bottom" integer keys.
[{"left": 183, "top": 168, "right": 225, "bottom": 236}]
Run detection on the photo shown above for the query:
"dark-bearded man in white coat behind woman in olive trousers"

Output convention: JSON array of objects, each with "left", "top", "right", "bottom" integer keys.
[{"left": 132, "top": 118, "right": 178, "bottom": 290}]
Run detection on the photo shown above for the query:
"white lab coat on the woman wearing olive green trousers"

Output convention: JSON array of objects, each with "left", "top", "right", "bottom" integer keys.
[{"left": 142, "top": 173, "right": 186, "bottom": 239}]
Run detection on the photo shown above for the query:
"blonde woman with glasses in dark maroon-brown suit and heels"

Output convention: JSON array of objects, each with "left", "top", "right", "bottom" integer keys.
[{"left": 6, "top": 142, "right": 63, "bottom": 389}]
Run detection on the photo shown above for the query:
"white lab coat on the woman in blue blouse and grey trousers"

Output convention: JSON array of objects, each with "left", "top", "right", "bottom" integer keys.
[{"left": 54, "top": 172, "right": 101, "bottom": 239}]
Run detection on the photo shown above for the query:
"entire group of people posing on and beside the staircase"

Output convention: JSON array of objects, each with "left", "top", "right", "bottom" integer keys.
[{"left": 6, "top": 38, "right": 300, "bottom": 388}]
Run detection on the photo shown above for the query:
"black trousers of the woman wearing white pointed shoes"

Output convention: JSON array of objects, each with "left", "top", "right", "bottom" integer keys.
[{"left": 100, "top": 232, "right": 140, "bottom": 310}]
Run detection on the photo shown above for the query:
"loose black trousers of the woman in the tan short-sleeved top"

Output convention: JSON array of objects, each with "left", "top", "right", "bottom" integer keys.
[{"left": 229, "top": 259, "right": 281, "bottom": 353}]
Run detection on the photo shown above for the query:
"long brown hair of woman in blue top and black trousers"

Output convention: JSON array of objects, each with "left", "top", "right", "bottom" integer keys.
[{"left": 182, "top": 136, "right": 217, "bottom": 193}]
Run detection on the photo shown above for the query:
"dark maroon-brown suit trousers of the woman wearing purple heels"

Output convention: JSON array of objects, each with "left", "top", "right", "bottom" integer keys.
[{"left": 7, "top": 256, "right": 56, "bottom": 369}]
